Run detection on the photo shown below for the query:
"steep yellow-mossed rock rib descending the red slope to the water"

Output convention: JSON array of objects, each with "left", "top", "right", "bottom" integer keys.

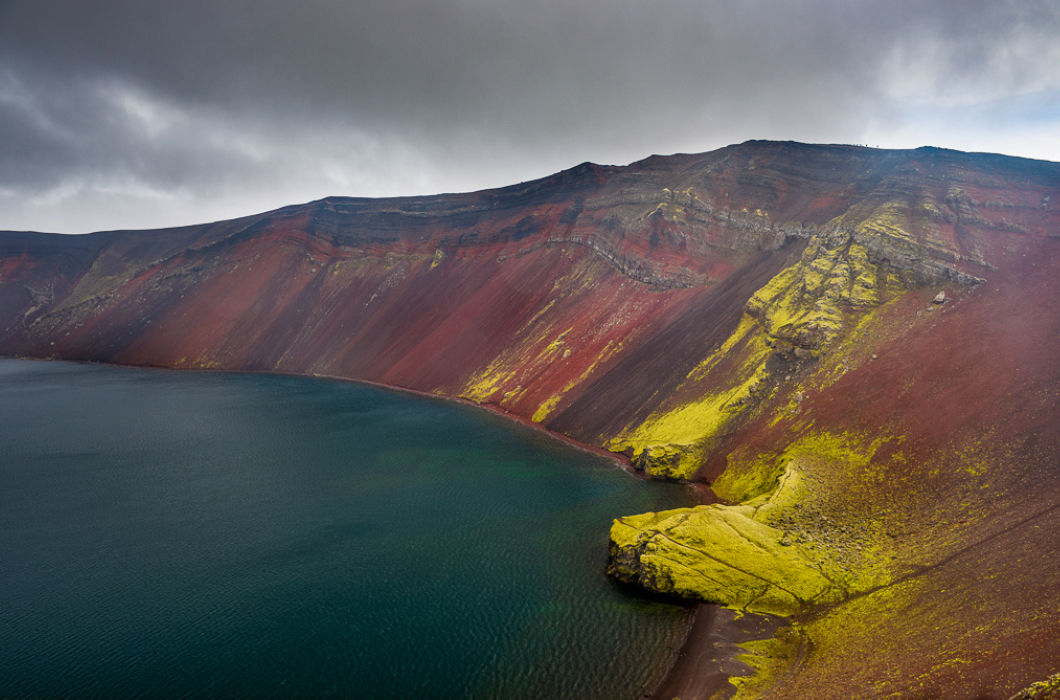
[{"left": 607, "top": 221, "right": 914, "bottom": 478}]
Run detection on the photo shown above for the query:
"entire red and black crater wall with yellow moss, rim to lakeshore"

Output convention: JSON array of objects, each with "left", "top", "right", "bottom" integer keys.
[{"left": 0, "top": 142, "right": 1060, "bottom": 697}]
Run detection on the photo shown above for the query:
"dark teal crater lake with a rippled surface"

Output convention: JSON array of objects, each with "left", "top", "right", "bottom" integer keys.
[{"left": 0, "top": 360, "right": 691, "bottom": 698}]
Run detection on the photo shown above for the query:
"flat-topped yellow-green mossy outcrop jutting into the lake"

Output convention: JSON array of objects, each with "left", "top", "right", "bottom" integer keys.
[{"left": 608, "top": 428, "right": 889, "bottom": 615}]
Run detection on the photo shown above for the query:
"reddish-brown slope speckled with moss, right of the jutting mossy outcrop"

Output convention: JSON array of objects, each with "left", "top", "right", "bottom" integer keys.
[{"left": 686, "top": 234, "right": 1060, "bottom": 699}]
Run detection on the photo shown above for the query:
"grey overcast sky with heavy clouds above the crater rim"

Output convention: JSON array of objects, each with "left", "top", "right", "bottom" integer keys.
[{"left": 0, "top": 0, "right": 1060, "bottom": 232}]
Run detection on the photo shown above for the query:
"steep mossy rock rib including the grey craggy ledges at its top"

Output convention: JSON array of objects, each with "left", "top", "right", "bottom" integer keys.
[{"left": 607, "top": 183, "right": 985, "bottom": 478}]
